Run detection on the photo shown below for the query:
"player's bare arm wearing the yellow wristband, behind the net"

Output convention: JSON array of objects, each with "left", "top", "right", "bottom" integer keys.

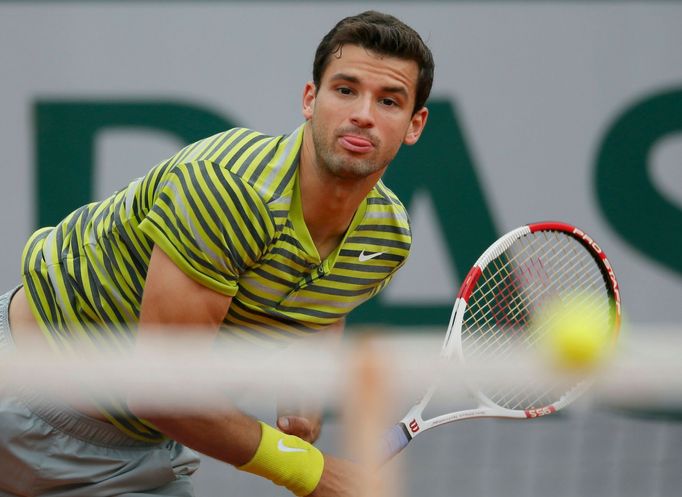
[{"left": 128, "top": 247, "right": 360, "bottom": 497}]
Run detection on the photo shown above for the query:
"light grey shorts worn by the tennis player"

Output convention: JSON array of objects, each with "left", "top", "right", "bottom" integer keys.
[{"left": 0, "top": 290, "right": 199, "bottom": 497}]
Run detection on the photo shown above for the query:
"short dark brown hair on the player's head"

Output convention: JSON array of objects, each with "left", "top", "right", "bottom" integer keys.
[{"left": 313, "top": 10, "right": 434, "bottom": 112}]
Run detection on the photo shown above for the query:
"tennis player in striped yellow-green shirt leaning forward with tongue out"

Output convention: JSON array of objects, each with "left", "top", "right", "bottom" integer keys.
[{"left": 0, "top": 11, "right": 433, "bottom": 497}]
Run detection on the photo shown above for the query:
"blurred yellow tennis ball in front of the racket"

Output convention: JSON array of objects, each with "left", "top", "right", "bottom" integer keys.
[{"left": 537, "top": 297, "right": 610, "bottom": 371}]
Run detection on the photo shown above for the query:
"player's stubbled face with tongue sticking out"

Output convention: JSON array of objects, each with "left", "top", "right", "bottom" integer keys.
[{"left": 303, "top": 45, "right": 428, "bottom": 178}]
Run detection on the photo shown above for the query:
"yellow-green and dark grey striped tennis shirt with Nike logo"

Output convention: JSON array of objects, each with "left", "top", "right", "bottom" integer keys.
[{"left": 22, "top": 125, "right": 411, "bottom": 441}]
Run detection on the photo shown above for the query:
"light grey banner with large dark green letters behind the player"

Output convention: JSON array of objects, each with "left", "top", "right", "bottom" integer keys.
[{"left": 0, "top": 0, "right": 682, "bottom": 328}]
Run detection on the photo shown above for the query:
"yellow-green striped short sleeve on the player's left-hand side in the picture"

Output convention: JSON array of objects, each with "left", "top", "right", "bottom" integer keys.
[{"left": 140, "top": 161, "right": 274, "bottom": 296}]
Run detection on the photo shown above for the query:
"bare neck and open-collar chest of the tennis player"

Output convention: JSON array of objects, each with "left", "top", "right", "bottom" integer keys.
[{"left": 299, "top": 123, "right": 381, "bottom": 259}]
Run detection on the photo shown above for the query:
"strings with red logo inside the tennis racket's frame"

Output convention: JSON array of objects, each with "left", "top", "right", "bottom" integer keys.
[{"left": 462, "top": 232, "right": 612, "bottom": 409}]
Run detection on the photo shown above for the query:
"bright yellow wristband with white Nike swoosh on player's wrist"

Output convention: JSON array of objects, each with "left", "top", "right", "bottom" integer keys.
[{"left": 237, "top": 421, "right": 324, "bottom": 497}]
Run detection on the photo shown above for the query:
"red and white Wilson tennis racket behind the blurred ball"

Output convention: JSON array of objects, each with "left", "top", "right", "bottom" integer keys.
[{"left": 382, "top": 222, "right": 621, "bottom": 460}]
